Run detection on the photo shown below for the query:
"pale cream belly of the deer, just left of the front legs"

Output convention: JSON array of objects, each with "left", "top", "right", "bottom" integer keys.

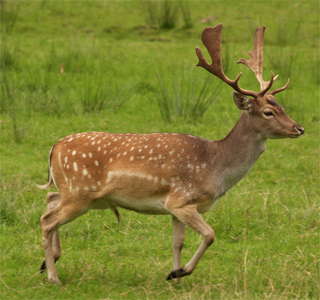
[{"left": 108, "top": 195, "right": 169, "bottom": 214}]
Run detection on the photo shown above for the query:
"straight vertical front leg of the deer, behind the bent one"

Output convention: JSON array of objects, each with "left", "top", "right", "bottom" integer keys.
[{"left": 172, "top": 216, "right": 185, "bottom": 270}]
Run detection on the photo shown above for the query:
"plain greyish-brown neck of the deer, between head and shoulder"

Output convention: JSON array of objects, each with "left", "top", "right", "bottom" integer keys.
[{"left": 210, "top": 112, "right": 266, "bottom": 196}]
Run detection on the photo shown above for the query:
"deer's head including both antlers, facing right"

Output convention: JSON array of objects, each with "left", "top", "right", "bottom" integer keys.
[{"left": 196, "top": 24, "right": 304, "bottom": 138}]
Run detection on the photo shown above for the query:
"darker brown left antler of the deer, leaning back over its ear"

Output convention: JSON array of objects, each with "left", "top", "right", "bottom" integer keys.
[{"left": 196, "top": 24, "right": 258, "bottom": 97}]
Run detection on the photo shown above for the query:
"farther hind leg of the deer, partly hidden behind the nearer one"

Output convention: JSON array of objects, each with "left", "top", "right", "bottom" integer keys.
[{"left": 40, "top": 192, "right": 61, "bottom": 273}]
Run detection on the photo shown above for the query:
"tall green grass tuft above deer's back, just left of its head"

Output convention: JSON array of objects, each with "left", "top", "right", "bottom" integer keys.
[{"left": 156, "top": 68, "right": 222, "bottom": 122}]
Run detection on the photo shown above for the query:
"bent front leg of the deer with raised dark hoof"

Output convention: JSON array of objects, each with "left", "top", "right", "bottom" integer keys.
[{"left": 166, "top": 199, "right": 215, "bottom": 280}]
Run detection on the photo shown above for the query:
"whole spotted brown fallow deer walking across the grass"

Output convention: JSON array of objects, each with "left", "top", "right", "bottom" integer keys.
[{"left": 40, "top": 24, "right": 304, "bottom": 283}]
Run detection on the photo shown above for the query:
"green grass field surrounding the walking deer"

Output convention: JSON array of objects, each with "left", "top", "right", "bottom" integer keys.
[{"left": 0, "top": 0, "right": 320, "bottom": 300}]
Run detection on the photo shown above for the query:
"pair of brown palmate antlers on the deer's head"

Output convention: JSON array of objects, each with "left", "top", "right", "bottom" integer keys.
[{"left": 196, "top": 24, "right": 289, "bottom": 98}]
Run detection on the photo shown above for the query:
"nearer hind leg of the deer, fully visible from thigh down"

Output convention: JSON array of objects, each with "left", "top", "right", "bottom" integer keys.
[{"left": 41, "top": 198, "right": 88, "bottom": 284}]
